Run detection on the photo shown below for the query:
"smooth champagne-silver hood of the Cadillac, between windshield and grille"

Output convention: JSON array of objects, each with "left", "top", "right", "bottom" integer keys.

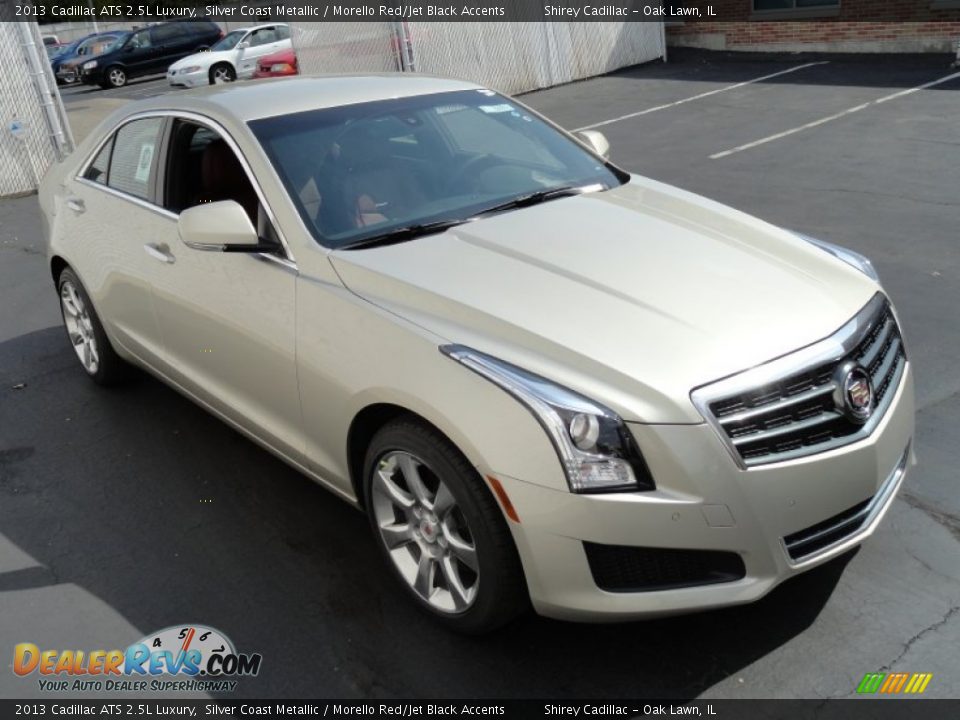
[{"left": 330, "top": 178, "right": 878, "bottom": 423}]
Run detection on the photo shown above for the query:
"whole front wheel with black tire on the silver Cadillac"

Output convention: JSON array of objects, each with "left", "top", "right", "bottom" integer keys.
[{"left": 363, "top": 418, "right": 529, "bottom": 635}]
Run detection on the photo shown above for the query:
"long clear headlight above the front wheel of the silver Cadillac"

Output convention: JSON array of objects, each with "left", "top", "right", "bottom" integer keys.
[{"left": 440, "top": 345, "right": 655, "bottom": 493}]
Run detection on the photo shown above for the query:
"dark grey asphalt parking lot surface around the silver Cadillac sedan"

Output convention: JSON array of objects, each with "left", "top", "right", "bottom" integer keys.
[{"left": 0, "top": 49, "right": 960, "bottom": 699}]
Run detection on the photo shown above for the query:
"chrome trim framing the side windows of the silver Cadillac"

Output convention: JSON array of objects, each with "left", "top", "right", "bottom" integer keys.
[{"left": 73, "top": 110, "right": 297, "bottom": 270}]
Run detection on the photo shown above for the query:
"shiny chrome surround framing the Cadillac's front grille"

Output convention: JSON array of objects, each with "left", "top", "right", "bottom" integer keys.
[{"left": 690, "top": 292, "right": 909, "bottom": 472}]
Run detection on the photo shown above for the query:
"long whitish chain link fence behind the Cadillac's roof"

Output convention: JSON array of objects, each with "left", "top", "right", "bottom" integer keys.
[{"left": 292, "top": 22, "right": 666, "bottom": 93}]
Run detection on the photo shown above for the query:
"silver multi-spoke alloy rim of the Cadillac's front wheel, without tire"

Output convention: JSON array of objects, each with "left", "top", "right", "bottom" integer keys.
[{"left": 372, "top": 450, "right": 480, "bottom": 613}]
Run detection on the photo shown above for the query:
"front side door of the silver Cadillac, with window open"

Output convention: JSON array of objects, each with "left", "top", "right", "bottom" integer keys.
[{"left": 145, "top": 115, "right": 304, "bottom": 458}]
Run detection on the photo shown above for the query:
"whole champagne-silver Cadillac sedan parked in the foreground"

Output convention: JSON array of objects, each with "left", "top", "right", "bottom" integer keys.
[{"left": 40, "top": 75, "right": 914, "bottom": 633}]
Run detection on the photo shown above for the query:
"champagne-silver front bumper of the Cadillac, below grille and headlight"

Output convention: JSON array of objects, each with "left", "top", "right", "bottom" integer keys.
[{"left": 497, "top": 363, "right": 914, "bottom": 621}]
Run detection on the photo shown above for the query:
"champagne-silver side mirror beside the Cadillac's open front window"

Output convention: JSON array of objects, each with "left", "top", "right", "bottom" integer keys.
[{"left": 177, "top": 200, "right": 266, "bottom": 253}]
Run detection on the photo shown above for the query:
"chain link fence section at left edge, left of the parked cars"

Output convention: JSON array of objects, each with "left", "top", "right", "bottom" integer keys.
[{"left": 0, "top": 16, "right": 73, "bottom": 197}]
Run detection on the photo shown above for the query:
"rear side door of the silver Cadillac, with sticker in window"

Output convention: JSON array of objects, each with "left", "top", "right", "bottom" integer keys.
[{"left": 55, "top": 117, "right": 170, "bottom": 362}]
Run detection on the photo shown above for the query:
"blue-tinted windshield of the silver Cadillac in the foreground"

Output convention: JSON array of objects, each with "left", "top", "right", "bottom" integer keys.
[{"left": 250, "top": 90, "right": 623, "bottom": 248}]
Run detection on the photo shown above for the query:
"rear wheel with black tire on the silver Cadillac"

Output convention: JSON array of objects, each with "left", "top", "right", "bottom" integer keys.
[{"left": 57, "top": 268, "right": 130, "bottom": 386}]
